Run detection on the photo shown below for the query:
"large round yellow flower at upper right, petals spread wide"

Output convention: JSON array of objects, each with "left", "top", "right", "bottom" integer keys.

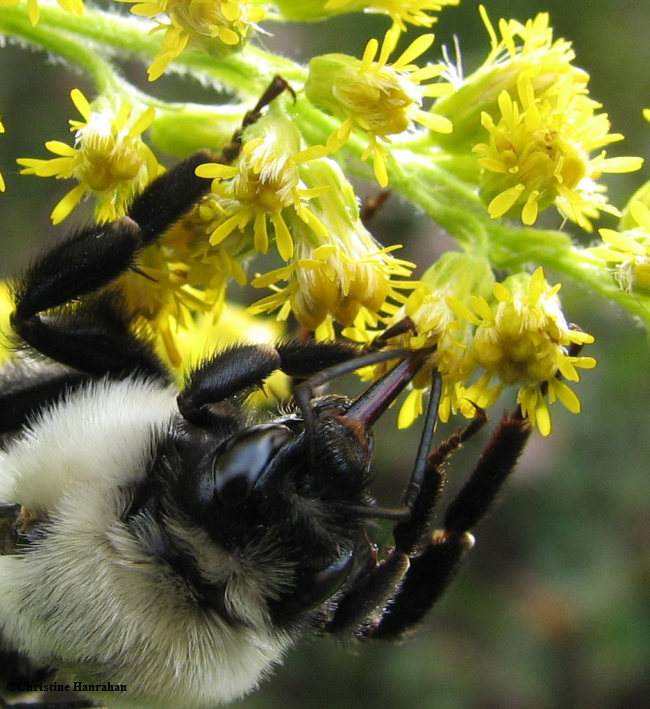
[{"left": 474, "top": 80, "right": 642, "bottom": 231}]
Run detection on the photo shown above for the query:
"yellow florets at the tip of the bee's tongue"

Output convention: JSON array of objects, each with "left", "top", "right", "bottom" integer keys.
[{"left": 362, "top": 253, "right": 596, "bottom": 435}]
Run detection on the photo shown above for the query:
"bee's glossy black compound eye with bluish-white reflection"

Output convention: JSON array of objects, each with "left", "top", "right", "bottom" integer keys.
[{"left": 212, "top": 424, "right": 292, "bottom": 507}]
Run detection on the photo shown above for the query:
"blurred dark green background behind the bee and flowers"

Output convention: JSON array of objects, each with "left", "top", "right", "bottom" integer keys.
[{"left": 0, "top": 0, "right": 650, "bottom": 709}]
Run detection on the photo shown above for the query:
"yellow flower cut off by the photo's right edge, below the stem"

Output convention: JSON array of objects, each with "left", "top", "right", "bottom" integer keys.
[{"left": 589, "top": 201, "right": 650, "bottom": 291}]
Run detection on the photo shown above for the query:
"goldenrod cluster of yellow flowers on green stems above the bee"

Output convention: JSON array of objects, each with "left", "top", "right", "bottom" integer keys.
[{"left": 7, "top": 0, "right": 650, "bottom": 435}]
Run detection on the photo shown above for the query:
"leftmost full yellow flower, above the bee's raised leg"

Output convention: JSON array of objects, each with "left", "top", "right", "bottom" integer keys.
[{"left": 18, "top": 89, "right": 162, "bottom": 224}]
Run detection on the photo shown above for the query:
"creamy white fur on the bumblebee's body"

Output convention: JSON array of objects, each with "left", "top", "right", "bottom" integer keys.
[{"left": 0, "top": 378, "right": 290, "bottom": 707}]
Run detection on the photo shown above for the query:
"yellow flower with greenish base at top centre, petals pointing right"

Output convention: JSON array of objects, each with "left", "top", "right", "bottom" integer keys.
[{"left": 305, "top": 25, "right": 452, "bottom": 186}]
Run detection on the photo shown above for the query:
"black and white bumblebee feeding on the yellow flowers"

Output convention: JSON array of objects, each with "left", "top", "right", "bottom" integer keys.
[{"left": 0, "top": 80, "right": 529, "bottom": 709}]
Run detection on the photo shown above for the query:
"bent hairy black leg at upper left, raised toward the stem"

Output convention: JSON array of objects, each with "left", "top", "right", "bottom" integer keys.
[{"left": 11, "top": 155, "right": 209, "bottom": 378}]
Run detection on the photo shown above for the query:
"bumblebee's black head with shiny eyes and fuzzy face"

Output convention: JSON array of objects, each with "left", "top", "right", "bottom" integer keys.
[{"left": 151, "top": 396, "right": 373, "bottom": 621}]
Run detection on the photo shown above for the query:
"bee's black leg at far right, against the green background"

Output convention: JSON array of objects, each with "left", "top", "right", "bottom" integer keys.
[{"left": 368, "top": 412, "right": 530, "bottom": 639}]
